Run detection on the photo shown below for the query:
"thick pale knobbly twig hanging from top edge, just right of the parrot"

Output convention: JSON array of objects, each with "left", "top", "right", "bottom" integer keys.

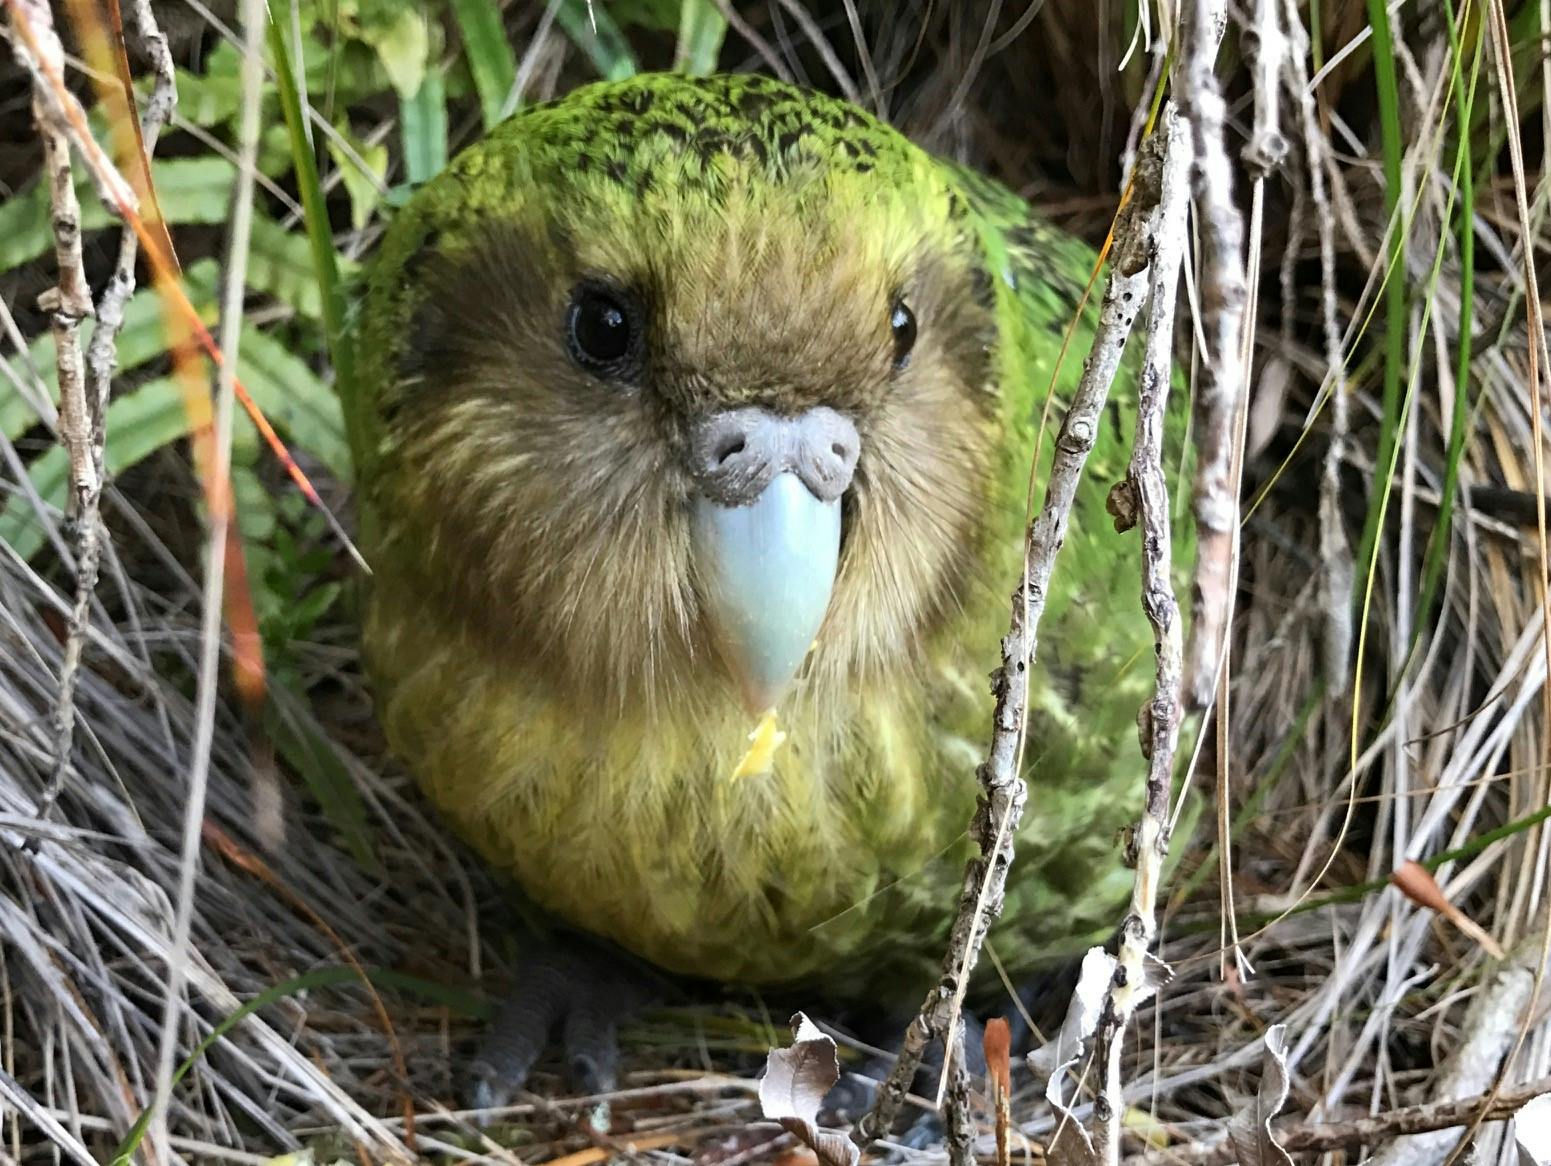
[{"left": 1176, "top": 0, "right": 1247, "bottom": 709}]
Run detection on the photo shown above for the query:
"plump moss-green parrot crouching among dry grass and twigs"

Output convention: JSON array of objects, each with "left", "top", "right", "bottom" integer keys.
[{"left": 347, "top": 74, "right": 1172, "bottom": 1103}]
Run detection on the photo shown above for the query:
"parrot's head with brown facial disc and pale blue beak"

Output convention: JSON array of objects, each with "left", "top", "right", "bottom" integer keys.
[{"left": 354, "top": 76, "right": 1000, "bottom": 710}]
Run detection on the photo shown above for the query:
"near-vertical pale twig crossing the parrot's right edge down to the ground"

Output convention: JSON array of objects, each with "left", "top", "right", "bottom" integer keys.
[{"left": 1095, "top": 105, "right": 1191, "bottom": 1161}]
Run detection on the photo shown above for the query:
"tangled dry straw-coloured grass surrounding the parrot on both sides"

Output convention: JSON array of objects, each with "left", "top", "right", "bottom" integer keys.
[{"left": 0, "top": 0, "right": 1551, "bottom": 1163}]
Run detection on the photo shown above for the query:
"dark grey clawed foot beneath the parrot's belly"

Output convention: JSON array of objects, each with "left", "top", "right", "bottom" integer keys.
[{"left": 468, "top": 935, "right": 651, "bottom": 1129}]
